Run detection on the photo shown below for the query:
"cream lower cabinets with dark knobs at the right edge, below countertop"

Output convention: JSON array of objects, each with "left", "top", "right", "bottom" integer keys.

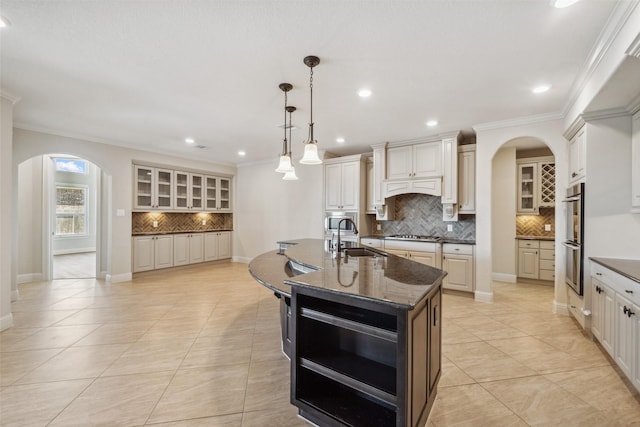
[{"left": 591, "top": 262, "right": 640, "bottom": 391}]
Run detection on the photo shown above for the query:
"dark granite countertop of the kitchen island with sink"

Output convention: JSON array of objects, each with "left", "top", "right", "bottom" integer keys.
[{"left": 249, "top": 239, "right": 447, "bottom": 309}]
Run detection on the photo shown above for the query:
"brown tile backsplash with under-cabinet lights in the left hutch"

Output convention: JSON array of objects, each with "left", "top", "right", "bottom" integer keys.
[{"left": 131, "top": 212, "right": 233, "bottom": 234}]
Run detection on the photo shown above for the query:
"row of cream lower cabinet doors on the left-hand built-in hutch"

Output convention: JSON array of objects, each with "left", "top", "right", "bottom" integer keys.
[{"left": 132, "top": 231, "right": 231, "bottom": 273}]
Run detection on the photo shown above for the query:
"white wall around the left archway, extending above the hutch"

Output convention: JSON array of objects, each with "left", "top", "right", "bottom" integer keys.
[{"left": 12, "top": 130, "right": 236, "bottom": 282}]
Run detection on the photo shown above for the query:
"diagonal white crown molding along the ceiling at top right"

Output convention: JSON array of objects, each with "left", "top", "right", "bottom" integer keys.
[{"left": 562, "top": 0, "right": 640, "bottom": 116}]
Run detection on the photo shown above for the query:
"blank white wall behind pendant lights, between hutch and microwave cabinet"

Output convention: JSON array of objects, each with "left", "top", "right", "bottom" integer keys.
[{"left": 233, "top": 157, "right": 324, "bottom": 262}]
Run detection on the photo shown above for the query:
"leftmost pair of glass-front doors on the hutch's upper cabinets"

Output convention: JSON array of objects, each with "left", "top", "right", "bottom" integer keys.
[{"left": 133, "top": 165, "right": 174, "bottom": 210}]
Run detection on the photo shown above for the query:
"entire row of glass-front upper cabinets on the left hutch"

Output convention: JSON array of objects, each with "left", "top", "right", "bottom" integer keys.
[{"left": 133, "top": 165, "right": 232, "bottom": 212}]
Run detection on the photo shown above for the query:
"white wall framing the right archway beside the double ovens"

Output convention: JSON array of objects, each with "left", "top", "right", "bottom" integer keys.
[{"left": 475, "top": 119, "right": 568, "bottom": 308}]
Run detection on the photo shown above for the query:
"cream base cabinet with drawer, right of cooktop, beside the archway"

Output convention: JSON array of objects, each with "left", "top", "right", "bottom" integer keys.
[{"left": 442, "top": 243, "right": 475, "bottom": 292}]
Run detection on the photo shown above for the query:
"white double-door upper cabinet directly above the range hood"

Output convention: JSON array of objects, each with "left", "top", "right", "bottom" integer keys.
[{"left": 387, "top": 142, "right": 442, "bottom": 180}]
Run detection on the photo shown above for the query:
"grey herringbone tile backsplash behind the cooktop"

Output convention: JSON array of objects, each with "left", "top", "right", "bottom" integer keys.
[{"left": 374, "top": 194, "right": 476, "bottom": 240}]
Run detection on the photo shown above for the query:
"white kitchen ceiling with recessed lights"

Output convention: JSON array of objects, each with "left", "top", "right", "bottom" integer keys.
[{"left": 0, "top": 0, "right": 628, "bottom": 165}]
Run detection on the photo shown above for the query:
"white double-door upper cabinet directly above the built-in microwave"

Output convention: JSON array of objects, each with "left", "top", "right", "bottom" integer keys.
[{"left": 324, "top": 160, "right": 364, "bottom": 211}]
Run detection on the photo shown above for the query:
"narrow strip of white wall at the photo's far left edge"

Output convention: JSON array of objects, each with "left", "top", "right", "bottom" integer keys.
[{"left": 0, "top": 96, "right": 16, "bottom": 331}]
